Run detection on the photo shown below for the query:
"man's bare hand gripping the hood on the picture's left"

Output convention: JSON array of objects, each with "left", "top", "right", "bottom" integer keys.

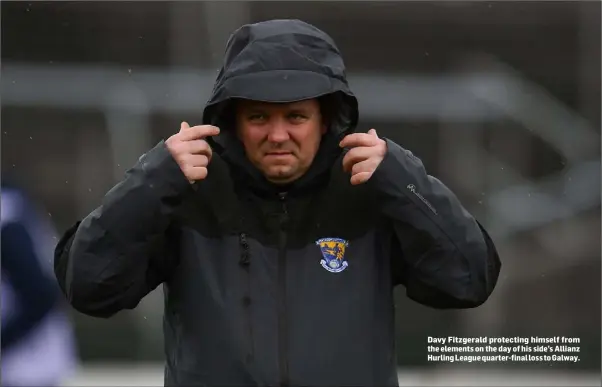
[{"left": 165, "top": 122, "right": 219, "bottom": 183}]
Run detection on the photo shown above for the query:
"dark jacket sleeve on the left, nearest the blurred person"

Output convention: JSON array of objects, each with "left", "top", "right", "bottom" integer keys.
[{"left": 54, "top": 142, "right": 191, "bottom": 317}]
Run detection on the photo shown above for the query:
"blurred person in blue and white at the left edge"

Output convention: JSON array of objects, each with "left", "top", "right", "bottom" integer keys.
[{"left": 0, "top": 177, "right": 77, "bottom": 387}]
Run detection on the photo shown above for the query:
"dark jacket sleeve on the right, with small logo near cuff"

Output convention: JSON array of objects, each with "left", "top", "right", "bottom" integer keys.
[{"left": 369, "top": 140, "right": 501, "bottom": 309}]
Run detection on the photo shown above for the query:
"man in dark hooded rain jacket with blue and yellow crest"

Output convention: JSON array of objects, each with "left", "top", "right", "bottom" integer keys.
[{"left": 55, "top": 20, "right": 500, "bottom": 386}]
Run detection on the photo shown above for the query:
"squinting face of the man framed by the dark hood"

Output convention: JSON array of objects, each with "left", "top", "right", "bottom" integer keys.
[{"left": 236, "top": 99, "right": 326, "bottom": 184}]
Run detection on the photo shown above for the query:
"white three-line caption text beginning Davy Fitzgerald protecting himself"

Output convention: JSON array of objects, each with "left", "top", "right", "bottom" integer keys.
[{"left": 427, "top": 336, "right": 581, "bottom": 363}]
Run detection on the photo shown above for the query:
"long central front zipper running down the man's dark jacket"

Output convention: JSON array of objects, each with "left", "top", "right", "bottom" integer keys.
[{"left": 278, "top": 192, "right": 290, "bottom": 387}]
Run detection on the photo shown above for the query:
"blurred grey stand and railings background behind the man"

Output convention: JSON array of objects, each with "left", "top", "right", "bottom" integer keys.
[{"left": 1, "top": 1, "right": 601, "bottom": 386}]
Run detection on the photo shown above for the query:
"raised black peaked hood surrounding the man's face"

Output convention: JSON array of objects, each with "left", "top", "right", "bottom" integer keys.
[{"left": 203, "top": 20, "right": 358, "bottom": 197}]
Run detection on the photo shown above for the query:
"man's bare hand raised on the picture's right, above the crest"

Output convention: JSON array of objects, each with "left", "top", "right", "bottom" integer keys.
[{"left": 339, "top": 129, "right": 387, "bottom": 185}]
